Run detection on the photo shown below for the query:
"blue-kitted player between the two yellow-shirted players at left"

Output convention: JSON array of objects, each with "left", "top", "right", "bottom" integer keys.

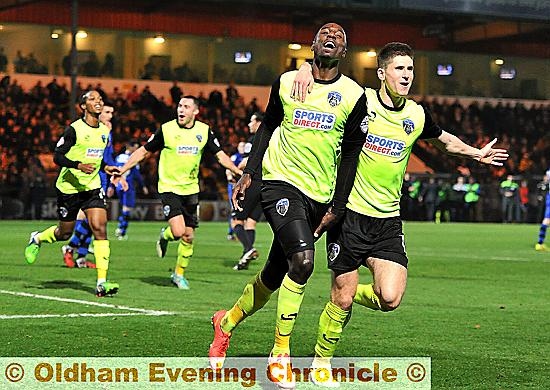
[{"left": 107, "top": 140, "right": 149, "bottom": 240}]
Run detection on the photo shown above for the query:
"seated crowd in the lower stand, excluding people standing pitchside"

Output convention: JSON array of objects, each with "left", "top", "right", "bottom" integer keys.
[{"left": 0, "top": 76, "right": 550, "bottom": 219}]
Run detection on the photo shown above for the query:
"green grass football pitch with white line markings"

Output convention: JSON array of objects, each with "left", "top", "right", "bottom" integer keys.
[{"left": 0, "top": 221, "right": 550, "bottom": 389}]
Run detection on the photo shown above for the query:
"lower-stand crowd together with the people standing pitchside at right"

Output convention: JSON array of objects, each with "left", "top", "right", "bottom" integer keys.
[{"left": 0, "top": 76, "right": 550, "bottom": 222}]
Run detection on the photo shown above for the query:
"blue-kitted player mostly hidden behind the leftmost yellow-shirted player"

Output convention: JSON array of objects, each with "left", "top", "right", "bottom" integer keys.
[{"left": 61, "top": 102, "right": 115, "bottom": 268}]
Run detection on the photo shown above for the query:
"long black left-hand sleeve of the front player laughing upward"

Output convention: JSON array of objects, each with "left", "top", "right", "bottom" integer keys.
[{"left": 243, "top": 76, "right": 284, "bottom": 176}]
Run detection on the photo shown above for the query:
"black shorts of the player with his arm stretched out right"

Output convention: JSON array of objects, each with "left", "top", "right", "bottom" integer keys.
[{"left": 327, "top": 210, "right": 409, "bottom": 274}]
